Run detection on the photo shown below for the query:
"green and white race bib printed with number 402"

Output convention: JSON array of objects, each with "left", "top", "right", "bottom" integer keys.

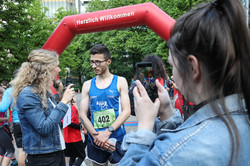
[{"left": 93, "top": 109, "right": 116, "bottom": 129}]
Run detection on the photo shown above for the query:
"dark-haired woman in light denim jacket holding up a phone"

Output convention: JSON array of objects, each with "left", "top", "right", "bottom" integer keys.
[{"left": 120, "top": 0, "right": 250, "bottom": 166}]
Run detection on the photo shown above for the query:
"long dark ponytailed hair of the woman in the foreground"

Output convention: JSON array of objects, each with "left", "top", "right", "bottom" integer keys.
[{"left": 168, "top": 0, "right": 250, "bottom": 164}]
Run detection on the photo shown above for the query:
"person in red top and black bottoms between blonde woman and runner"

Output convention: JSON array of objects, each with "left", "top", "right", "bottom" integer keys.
[{"left": 63, "top": 97, "right": 86, "bottom": 166}]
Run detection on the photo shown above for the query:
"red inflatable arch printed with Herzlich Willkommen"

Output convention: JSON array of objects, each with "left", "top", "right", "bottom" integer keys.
[{"left": 42, "top": 3, "right": 175, "bottom": 55}]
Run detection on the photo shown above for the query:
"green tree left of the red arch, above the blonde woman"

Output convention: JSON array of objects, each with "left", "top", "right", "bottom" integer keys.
[{"left": 0, "top": 0, "right": 55, "bottom": 80}]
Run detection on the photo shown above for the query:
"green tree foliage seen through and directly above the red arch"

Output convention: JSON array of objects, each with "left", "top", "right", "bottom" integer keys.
[{"left": 71, "top": 0, "right": 205, "bottom": 85}]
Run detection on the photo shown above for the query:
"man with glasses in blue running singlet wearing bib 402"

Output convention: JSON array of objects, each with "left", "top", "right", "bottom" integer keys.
[{"left": 80, "top": 44, "right": 130, "bottom": 166}]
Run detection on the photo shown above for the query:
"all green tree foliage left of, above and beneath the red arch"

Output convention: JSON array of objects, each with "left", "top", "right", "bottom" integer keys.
[{"left": 0, "top": 0, "right": 207, "bottom": 87}]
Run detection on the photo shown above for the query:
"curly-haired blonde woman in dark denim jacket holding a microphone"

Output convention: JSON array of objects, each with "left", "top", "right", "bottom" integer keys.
[{"left": 12, "top": 49, "right": 75, "bottom": 166}]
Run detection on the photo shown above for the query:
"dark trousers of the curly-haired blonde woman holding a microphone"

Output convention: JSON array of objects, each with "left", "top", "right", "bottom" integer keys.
[{"left": 25, "top": 151, "right": 66, "bottom": 166}]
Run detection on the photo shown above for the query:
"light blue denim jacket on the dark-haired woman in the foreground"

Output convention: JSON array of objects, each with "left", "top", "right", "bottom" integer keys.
[{"left": 119, "top": 94, "right": 250, "bottom": 166}]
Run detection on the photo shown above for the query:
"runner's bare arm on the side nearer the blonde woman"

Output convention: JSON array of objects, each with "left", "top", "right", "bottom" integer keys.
[{"left": 79, "top": 80, "right": 96, "bottom": 139}]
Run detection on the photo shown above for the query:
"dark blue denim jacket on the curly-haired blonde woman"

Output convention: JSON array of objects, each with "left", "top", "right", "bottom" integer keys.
[{"left": 16, "top": 86, "right": 68, "bottom": 154}]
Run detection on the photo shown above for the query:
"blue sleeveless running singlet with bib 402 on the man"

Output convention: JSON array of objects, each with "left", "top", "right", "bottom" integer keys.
[{"left": 89, "top": 75, "right": 126, "bottom": 141}]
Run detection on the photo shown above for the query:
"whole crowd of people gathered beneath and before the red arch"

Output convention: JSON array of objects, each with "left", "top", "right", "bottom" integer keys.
[{"left": 0, "top": 0, "right": 250, "bottom": 166}]
